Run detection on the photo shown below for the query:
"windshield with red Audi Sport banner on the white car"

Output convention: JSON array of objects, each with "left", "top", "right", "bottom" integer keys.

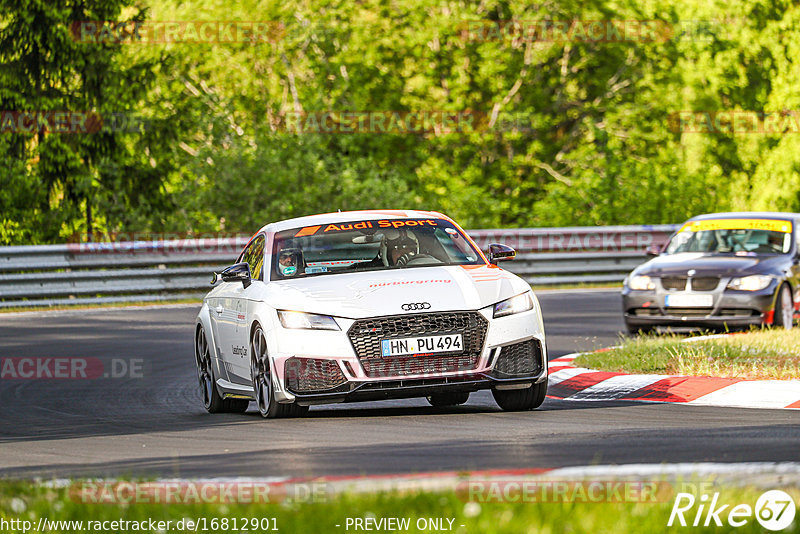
[{"left": 271, "top": 219, "right": 483, "bottom": 280}]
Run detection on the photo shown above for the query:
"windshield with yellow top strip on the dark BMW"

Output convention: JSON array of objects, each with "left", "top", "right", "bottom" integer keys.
[{"left": 666, "top": 219, "right": 792, "bottom": 256}]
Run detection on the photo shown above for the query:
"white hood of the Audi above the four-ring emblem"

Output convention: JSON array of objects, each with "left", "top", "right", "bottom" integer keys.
[{"left": 264, "top": 265, "right": 530, "bottom": 319}]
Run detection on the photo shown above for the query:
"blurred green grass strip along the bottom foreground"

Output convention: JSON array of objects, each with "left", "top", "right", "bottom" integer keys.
[{"left": 0, "top": 482, "right": 800, "bottom": 534}]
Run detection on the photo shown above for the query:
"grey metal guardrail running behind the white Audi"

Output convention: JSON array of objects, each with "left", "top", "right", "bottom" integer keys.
[{"left": 0, "top": 225, "right": 677, "bottom": 308}]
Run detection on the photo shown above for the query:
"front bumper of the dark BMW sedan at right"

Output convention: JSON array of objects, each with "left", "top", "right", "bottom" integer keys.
[{"left": 622, "top": 279, "right": 777, "bottom": 328}]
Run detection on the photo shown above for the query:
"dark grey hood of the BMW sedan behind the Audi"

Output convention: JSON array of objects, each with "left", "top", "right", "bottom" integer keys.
[{"left": 634, "top": 252, "right": 784, "bottom": 277}]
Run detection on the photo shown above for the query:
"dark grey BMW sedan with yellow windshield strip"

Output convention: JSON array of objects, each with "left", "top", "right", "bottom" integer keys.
[{"left": 622, "top": 212, "right": 800, "bottom": 333}]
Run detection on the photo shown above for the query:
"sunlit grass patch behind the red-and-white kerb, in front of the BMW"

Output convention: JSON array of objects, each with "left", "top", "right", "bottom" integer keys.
[{"left": 575, "top": 329, "right": 800, "bottom": 380}]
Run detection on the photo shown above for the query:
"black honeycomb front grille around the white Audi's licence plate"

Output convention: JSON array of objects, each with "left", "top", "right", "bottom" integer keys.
[{"left": 347, "top": 312, "right": 489, "bottom": 378}]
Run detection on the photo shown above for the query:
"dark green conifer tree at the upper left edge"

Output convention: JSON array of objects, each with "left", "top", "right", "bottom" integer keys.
[{"left": 0, "top": 0, "right": 188, "bottom": 242}]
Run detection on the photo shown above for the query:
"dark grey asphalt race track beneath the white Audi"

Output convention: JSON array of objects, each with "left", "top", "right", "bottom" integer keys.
[{"left": 0, "top": 291, "right": 800, "bottom": 478}]
